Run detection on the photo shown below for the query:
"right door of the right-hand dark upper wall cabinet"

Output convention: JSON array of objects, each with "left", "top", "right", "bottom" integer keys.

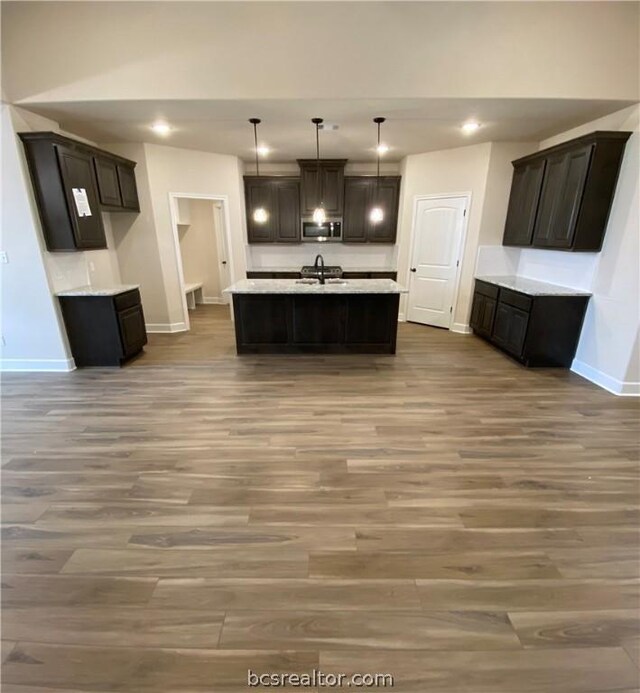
[{"left": 533, "top": 145, "right": 593, "bottom": 248}]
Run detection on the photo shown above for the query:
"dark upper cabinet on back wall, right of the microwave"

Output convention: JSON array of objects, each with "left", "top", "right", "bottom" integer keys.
[{"left": 342, "top": 176, "right": 400, "bottom": 243}]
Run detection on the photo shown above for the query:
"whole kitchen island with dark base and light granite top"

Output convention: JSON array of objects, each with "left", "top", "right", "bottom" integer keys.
[{"left": 225, "top": 279, "right": 406, "bottom": 354}]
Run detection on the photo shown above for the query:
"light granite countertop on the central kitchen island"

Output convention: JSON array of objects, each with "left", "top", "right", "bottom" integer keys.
[{"left": 224, "top": 279, "right": 407, "bottom": 294}]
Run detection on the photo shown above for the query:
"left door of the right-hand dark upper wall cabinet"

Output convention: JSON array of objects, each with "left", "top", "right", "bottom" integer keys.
[{"left": 502, "top": 159, "right": 546, "bottom": 246}]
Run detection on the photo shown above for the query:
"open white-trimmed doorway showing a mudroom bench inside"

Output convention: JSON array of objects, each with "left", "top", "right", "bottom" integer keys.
[{"left": 169, "top": 193, "right": 233, "bottom": 330}]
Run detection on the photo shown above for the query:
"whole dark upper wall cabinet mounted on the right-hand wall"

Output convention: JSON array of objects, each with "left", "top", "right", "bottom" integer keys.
[{"left": 502, "top": 131, "right": 631, "bottom": 251}]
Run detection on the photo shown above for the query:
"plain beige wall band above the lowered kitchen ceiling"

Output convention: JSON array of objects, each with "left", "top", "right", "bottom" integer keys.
[{"left": 2, "top": 2, "right": 639, "bottom": 102}]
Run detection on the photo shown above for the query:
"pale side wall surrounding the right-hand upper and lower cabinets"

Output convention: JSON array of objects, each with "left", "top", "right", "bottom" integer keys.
[{"left": 518, "top": 106, "right": 640, "bottom": 394}]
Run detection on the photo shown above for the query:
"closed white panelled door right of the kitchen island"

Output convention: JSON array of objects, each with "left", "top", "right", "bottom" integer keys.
[{"left": 407, "top": 197, "right": 467, "bottom": 329}]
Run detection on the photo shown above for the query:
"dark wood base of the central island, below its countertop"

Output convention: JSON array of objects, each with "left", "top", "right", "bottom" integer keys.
[{"left": 233, "top": 294, "right": 400, "bottom": 354}]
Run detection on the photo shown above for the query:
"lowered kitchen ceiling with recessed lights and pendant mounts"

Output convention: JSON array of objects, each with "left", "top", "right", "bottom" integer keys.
[{"left": 23, "top": 98, "right": 633, "bottom": 162}]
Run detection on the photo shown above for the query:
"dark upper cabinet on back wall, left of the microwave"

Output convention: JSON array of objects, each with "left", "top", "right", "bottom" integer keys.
[{"left": 244, "top": 176, "right": 300, "bottom": 243}]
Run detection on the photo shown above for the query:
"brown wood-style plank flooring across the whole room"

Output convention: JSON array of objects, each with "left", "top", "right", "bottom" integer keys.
[{"left": 2, "top": 306, "right": 640, "bottom": 693}]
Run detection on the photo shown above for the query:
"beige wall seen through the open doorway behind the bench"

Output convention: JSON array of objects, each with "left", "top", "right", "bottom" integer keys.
[{"left": 178, "top": 199, "right": 225, "bottom": 302}]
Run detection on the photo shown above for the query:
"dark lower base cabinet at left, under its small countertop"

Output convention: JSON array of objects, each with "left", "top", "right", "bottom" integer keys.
[{"left": 59, "top": 289, "right": 147, "bottom": 368}]
